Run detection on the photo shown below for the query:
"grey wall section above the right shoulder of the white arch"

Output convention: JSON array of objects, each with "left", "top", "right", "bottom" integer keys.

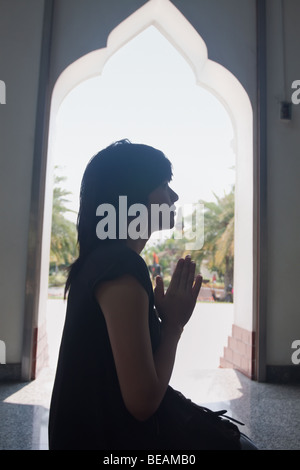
[{"left": 172, "top": 0, "right": 257, "bottom": 106}]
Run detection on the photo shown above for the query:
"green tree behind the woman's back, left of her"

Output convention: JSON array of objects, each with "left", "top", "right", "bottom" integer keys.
[{"left": 50, "top": 167, "right": 77, "bottom": 278}]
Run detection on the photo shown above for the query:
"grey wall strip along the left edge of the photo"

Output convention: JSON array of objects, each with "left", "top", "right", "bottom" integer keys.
[{"left": 0, "top": 0, "right": 44, "bottom": 364}]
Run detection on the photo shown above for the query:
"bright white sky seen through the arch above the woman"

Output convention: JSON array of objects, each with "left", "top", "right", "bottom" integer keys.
[{"left": 54, "top": 26, "right": 235, "bottom": 221}]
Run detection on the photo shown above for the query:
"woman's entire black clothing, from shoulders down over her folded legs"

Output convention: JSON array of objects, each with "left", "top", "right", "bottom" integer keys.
[{"left": 49, "top": 244, "right": 240, "bottom": 450}]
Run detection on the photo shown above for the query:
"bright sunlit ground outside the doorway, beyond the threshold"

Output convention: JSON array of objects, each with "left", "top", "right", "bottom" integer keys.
[{"left": 47, "top": 299, "right": 233, "bottom": 386}]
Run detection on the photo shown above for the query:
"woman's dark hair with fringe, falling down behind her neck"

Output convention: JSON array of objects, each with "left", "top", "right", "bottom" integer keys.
[{"left": 65, "top": 139, "right": 172, "bottom": 296}]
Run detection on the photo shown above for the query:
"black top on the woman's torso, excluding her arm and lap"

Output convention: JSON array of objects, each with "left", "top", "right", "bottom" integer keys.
[{"left": 49, "top": 244, "right": 160, "bottom": 449}]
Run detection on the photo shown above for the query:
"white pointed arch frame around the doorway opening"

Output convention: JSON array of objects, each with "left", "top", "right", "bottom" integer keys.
[{"left": 40, "top": 0, "right": 254, "bottom": 331}]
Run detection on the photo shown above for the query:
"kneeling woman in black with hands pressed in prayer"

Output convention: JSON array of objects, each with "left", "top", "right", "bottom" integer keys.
[{"left": 49, "top": 140, "right": 252, "bottom": 451}]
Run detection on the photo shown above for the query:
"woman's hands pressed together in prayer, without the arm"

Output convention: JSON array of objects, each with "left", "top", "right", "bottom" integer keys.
[{"left": 154, "top": 255, "right": 202, "bottom": 331}]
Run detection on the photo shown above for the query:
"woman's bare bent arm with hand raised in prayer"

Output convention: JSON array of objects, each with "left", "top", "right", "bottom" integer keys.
[{"left": 95, "top": 260, "right": 201, "bottom": 421}]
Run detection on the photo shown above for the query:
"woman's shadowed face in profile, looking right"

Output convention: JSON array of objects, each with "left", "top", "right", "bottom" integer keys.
[{"left": 148, "top": 181, "right": 178, "bottom": 231}]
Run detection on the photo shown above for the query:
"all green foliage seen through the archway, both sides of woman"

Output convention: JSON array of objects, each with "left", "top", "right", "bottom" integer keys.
[{"left": 49, "top": 167, "right": 235, "bottom": 289}]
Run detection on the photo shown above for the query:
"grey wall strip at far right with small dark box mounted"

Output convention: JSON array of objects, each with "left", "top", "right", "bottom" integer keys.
[{"left": 267, "top": 0, "right": 300, "bottom": 367}]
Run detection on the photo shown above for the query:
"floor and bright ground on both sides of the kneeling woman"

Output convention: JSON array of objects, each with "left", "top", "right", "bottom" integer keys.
[{"left": 0, "top": 300, "right": 300, "bottom": 450}]
